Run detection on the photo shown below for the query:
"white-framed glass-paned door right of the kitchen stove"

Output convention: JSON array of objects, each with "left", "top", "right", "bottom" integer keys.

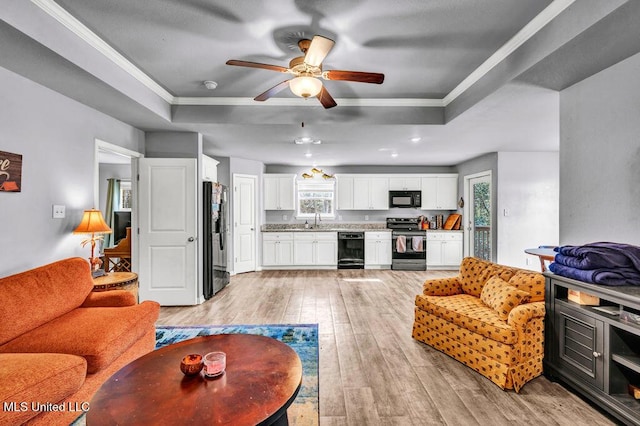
[{"left": 465, "top": 172, "right": 492, "bottom": 261}]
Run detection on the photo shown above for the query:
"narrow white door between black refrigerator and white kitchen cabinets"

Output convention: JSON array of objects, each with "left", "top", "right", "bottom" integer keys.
[{"left": 233, "top": 174, "right": 257, "bottom": 274}]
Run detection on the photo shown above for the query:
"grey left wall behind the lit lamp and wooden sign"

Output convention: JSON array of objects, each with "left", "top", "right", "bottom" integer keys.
[{"left": 0, "top": 68, "right": 144, "bottom": 276}]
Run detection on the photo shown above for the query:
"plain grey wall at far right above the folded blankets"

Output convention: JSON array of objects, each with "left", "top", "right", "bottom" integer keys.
[{"left": 560, "top": 54, "right": 640, "bottom": 245}]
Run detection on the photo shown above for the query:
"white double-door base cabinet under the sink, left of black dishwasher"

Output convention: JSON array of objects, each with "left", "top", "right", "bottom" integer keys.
[{"left": 293, "top": 232, "right": 338, "bottom": 267}]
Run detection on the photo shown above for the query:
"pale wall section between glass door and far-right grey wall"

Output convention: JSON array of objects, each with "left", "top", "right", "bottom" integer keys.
[{"left": 496, "top": 152, "right": 559, "bottom": 270}]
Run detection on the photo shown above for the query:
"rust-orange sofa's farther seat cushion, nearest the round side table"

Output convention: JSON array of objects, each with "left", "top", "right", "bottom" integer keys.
[{"left": 0, "top": 301, "right": 160, "bottom": 374}]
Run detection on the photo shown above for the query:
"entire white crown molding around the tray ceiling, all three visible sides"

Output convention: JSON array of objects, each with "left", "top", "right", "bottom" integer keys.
[{"left": 31, "top": 0, "right": 575, "bottom": 108}]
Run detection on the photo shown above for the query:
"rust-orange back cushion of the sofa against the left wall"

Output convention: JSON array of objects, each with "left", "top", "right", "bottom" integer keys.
[{"left": 0, "top": 257, "right": 93, "bottom": 345}]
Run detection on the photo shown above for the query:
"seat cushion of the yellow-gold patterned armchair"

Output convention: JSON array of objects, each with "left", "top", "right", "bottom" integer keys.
[{"left": 416, "top": 294, "right": 518, "bottom": 344}]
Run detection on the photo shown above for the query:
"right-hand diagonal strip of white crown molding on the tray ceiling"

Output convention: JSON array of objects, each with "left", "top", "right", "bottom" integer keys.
[{"left": 442, "top": 0, "right": 575, "bottom": 106}]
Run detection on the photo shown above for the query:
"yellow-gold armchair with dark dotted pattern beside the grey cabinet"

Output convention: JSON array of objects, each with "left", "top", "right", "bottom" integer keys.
[{"left": 413, "top": 257, "right": 545, "bottom": 392}]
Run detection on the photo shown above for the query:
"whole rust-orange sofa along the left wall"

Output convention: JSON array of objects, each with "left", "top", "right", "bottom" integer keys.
[{"left": 0, "top": 258, "right": 160, "bottom": 425}]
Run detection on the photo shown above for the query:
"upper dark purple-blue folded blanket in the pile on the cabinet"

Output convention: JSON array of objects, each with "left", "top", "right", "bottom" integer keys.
[{"left": 554, "top": 242, "right": 640, "bottom": 271}]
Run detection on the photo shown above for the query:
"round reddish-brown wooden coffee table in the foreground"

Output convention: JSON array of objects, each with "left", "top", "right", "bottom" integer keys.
[{"left": 87, "top": 334, "right": 302, "bottom": 426}]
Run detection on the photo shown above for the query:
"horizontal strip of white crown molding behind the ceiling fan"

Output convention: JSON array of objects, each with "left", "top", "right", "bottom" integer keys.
[{"left": 173, "top": 97, "right": 444, "bottom": 108}]
